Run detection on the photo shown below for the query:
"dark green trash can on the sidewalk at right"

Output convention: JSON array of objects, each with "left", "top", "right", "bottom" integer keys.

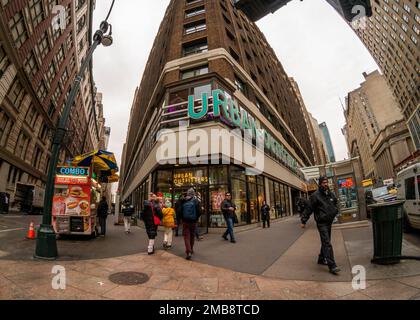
[{"left": 369, "top": 200, "right": 405, "bottom": 264}]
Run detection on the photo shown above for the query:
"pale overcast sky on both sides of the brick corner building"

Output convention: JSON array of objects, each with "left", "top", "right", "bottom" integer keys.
[{"left": 94, "top": 0, "right": 378, "bottom": 175}]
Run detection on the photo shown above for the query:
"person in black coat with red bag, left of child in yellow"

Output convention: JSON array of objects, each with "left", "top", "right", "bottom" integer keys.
[{"left": 140, "top": 193, "right": 163, "bottom": 254}]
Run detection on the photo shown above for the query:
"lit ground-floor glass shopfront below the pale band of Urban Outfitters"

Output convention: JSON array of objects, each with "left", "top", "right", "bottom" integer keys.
[{"left": 152, "top": 165, "right": 301, "bottom": 232}]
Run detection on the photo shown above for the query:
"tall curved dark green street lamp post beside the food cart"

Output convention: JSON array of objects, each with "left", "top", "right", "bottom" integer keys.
[{"left": 35, "top": 0, "right": 115, "bottom": 260}]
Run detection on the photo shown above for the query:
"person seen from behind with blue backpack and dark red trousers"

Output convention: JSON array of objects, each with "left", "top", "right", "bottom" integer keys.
[{"left": 182, "top": 188, "right": 201, "bottom": 260}]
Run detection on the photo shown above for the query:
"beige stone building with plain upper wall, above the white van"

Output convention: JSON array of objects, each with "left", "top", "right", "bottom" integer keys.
[{"left": 344, "top": 71, "right": 414, "bottom": 179}]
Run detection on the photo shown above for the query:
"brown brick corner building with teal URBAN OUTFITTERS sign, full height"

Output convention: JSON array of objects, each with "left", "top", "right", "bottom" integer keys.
[{"left": 121, "top": 0, "right": 314, "bottom": 230}]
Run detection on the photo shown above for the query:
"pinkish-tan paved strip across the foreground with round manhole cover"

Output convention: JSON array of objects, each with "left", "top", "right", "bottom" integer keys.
[{"left": 0, "top": 251, "right": 420, "bottom": 300}]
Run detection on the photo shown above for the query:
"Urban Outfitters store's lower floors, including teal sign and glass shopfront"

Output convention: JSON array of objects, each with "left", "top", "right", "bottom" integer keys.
[{"left": 123, "top": 85, "right": 306, "bottom": 232}]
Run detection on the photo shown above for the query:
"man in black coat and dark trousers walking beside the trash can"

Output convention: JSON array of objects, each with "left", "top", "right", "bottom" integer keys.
[{"left": 301, "top": 177, "right": 340, "bottom": 275}]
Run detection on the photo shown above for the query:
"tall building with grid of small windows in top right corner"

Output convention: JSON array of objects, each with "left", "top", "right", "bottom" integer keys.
[{"left": 352, "top": 0, "right": 420, "bottom": 155}]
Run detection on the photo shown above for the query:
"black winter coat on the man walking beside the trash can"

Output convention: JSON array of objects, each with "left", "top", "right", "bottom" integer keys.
[{"left": 301, "top": 189, "right": 338, "bottom": 226}]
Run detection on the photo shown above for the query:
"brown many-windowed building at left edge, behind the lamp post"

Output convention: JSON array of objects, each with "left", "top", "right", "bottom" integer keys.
[{"left": 0, "top": 0, "right": 98, "bottom": 210}]
